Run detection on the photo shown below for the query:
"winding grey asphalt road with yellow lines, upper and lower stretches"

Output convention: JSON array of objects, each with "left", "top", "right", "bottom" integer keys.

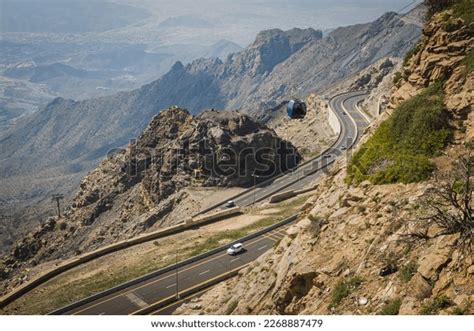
[{"left": 56, "top": 91, "right": 369, "bottom": 315}]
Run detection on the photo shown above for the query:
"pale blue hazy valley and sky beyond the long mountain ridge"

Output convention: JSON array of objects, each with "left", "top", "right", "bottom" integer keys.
[{"left": 0, "top": 0, "right": 412, "bottom": 130}]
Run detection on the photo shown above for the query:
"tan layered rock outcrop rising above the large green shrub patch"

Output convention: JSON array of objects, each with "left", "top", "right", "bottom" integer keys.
[{"left": 392, "top": 11, "right": 474, "bottom": 114}]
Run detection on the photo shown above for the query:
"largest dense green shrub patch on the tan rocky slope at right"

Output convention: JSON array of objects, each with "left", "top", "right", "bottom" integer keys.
[{"left": 347, "top": 83, "right": 451, "bottom": 184}]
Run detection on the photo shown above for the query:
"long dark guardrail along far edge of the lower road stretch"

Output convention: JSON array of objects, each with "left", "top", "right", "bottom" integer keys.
[{"left": 49, "top": 214, "right": 299, "bottom": 315}]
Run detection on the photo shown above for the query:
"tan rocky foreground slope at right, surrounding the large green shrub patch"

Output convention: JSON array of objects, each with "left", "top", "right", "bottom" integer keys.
[{"left": 176, "top": 5, "right": 474, "bottom": 314}]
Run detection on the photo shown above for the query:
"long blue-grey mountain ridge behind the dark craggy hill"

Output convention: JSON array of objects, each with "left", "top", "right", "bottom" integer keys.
[{"left": 0, "top": 13, "right": 421, "bottom": 230}]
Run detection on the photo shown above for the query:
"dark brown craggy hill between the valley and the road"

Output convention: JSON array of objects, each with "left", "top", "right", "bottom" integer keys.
[{"left": 0, "top": 107, "right": 300, "bottom": 285}]
